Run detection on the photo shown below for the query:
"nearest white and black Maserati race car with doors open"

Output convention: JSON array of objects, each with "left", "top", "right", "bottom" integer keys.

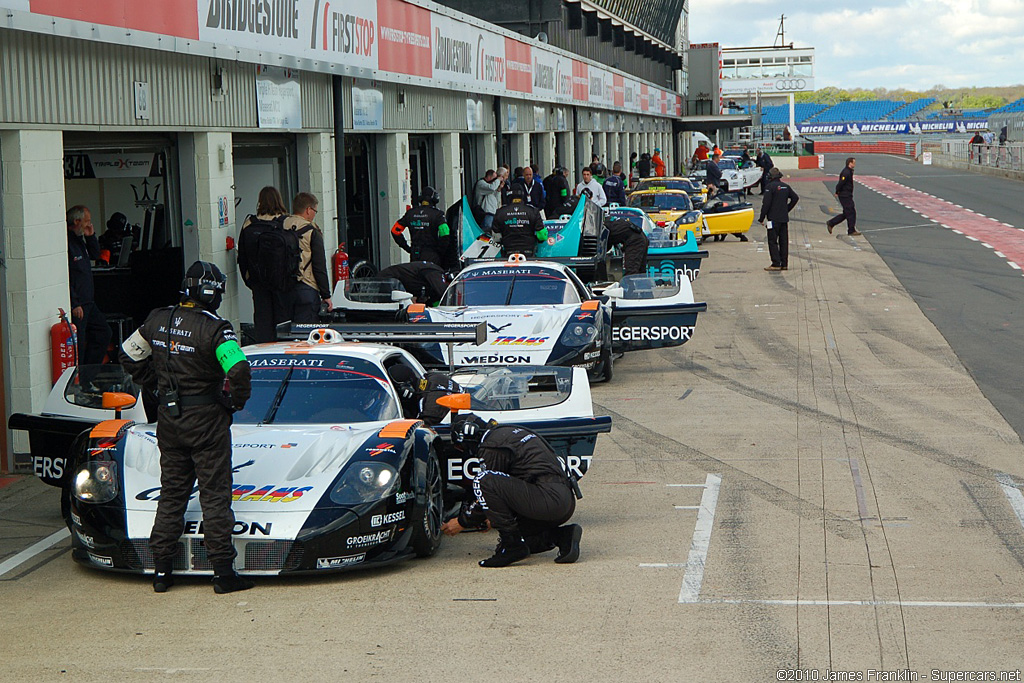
[{"left": 10, "top": 331, "right": 610, "bottom": 574}]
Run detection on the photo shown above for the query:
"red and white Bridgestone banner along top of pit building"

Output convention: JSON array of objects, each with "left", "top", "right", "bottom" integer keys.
[{"left": 8, "top": 0, "right": 682, "bottom": 116}]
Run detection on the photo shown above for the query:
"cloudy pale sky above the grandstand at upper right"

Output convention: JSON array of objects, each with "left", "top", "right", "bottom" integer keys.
[{"left": 689, "top": 0, "right": 1024, "bottom": 90}]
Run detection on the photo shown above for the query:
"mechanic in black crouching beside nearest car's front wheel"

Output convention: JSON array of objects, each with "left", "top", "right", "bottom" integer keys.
[{"left": 442, "top": 413, "right": 583, "bottom": 567}]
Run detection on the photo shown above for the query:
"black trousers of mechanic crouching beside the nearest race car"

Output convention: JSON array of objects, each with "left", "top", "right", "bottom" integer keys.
[{"left": 473, "top": 470, "right": 575, "bottom": 540}]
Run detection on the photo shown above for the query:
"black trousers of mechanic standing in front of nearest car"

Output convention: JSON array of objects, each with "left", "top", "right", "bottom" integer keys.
[{"left": 150, "top": 405, "right": 236, "bottom": 571}]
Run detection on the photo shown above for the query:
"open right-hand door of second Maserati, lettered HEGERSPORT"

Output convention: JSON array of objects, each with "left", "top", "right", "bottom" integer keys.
[{"left": 604, "top": 271, "right": 708, "bottom": 353}]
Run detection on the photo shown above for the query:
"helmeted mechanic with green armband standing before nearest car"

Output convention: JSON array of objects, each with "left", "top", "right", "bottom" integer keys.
[{"left": 120, "top": 261, "right": 253, "bottom": 593}]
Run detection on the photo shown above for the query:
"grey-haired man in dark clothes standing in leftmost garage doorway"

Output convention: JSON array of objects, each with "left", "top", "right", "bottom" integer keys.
[{"left": 67, "top": 205, "right": 111, "bottom": 366}]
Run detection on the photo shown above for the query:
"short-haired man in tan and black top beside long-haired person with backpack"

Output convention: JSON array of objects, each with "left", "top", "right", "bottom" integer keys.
[{"left": 285, "top": 193, "right": 332, "bottom": 323}]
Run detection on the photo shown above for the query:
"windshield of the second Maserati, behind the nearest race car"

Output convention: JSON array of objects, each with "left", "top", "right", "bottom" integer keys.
[{"left": 440, "top": 268, "right": 580, "bottom": 306}]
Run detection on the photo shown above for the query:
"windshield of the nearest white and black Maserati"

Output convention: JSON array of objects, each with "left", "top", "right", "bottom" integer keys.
[{"left": 234, "top": 366, "right": 401, "bottom": 424}]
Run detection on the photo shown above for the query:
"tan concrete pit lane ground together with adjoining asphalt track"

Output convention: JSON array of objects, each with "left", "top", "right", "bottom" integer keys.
[{"left": 0, "top": 157, "right": 1024, "bottom": 683}]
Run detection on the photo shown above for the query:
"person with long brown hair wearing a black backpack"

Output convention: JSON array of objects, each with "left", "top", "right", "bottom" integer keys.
[{"left": 239, "top": 185, "right": 297, "bottom": 344}]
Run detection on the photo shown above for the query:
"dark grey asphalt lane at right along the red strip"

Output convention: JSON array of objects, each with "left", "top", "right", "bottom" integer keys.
[{"left": 825, "top": 155, "right": 1024, "bottom": 437}]
